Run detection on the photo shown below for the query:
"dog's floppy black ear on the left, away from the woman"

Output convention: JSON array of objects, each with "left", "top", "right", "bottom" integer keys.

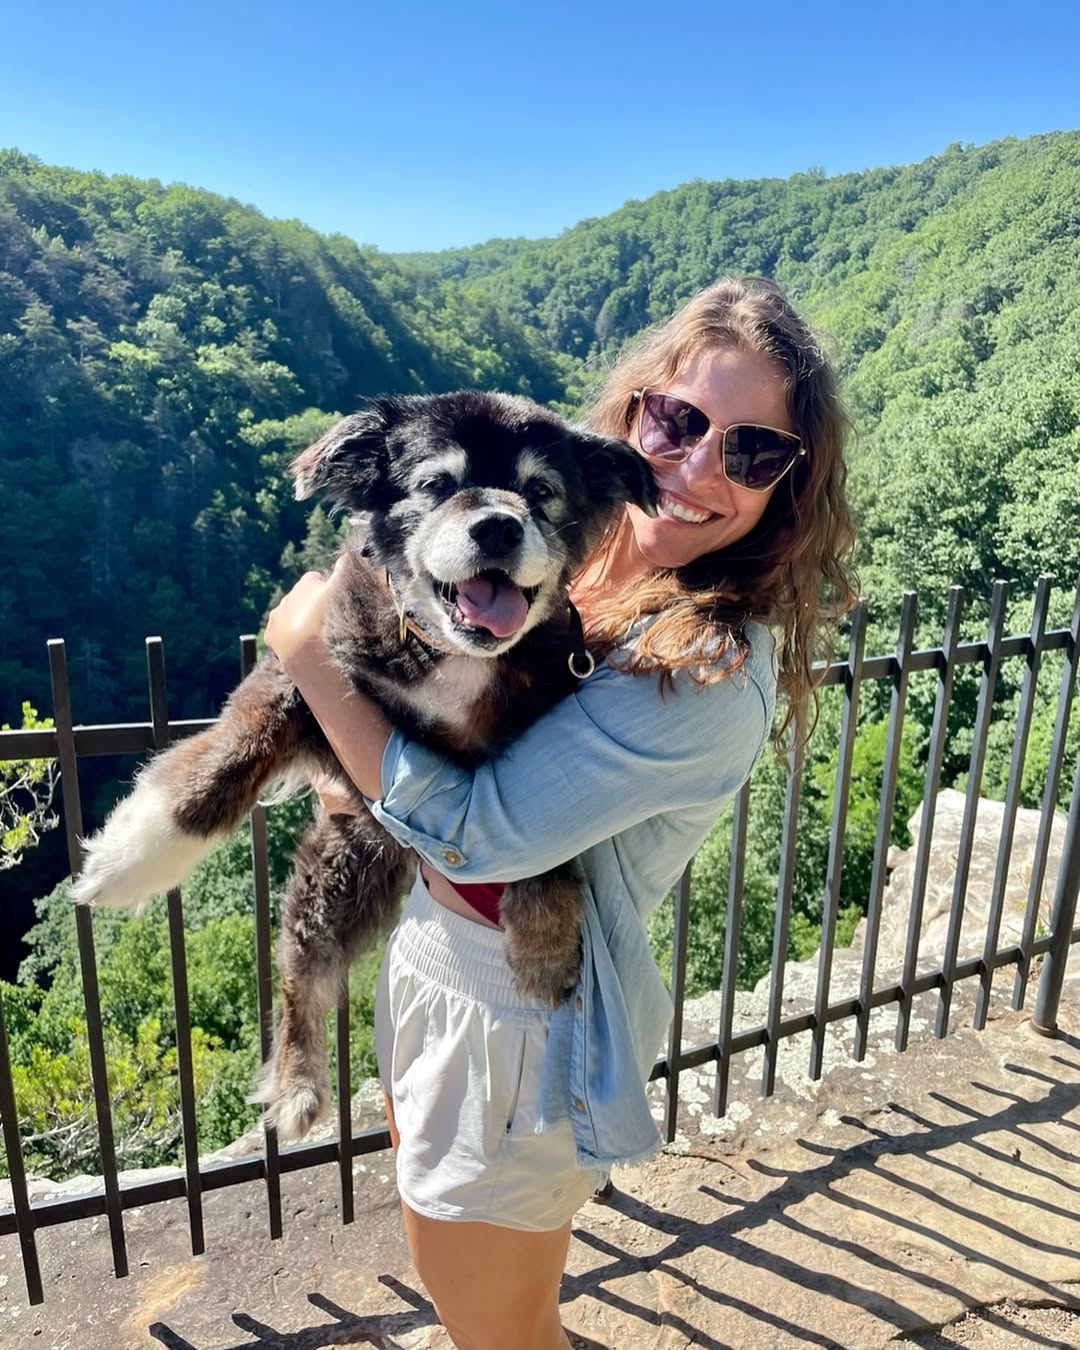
[{"left": 289, "top": 398, "right": 401, "bottom": 512}]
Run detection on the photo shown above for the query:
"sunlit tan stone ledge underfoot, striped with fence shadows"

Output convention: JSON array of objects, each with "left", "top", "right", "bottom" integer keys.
[{"left": 0, "top": 980, "right": 1080, "bottom": 1350}]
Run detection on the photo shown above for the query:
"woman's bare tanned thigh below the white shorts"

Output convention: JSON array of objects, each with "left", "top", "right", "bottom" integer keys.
[{"left": 383, "top": 1094, "right": 570, "bottom": 1350}]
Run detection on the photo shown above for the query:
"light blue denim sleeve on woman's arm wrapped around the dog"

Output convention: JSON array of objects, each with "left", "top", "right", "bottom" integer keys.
[{"left": 369, "top": 639, "right": 772, "bottom": 882}]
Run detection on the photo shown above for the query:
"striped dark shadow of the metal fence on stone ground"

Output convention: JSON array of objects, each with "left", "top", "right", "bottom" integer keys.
[{"left": 150, "top": 1053, "right": 1080, "bottom": 1350}]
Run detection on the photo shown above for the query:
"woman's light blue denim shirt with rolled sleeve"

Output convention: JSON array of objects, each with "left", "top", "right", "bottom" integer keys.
[{"left": 370, "top": 624, "right": 776, "bottom": 1175}]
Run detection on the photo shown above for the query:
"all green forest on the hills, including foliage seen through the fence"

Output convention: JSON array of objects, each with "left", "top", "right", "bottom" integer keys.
[{"left": 0, "top": 132, "right": 1080, "bottom": 1176}]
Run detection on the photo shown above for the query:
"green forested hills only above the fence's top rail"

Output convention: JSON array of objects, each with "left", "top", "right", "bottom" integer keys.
[{"left": 0, "top": 134, "right": 1080, "bottom": 721}]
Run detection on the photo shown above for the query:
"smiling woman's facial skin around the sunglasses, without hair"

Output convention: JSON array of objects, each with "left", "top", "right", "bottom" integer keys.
[{"left": 628, "top": 347, "right": 795, "bottom": 567}]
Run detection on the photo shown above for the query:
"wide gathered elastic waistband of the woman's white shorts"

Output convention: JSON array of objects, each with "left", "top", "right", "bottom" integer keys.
[{"left": 393, "top": 872, "right": 551, "bottom": 1013}]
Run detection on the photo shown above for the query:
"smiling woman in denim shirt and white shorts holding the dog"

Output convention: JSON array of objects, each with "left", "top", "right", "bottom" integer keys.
[{"left": 266, "top": 278, "right": 853, "bottom": 1350}]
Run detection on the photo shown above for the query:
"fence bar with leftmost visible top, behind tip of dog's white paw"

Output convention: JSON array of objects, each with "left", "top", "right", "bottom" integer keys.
[{"left": 47, "top": 637, "right": 127, "bottom": 1278}]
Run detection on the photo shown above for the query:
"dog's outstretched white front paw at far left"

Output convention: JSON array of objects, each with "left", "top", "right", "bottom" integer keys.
[{"left": 72, "top": 784, "right": 215, "bottom": 913}]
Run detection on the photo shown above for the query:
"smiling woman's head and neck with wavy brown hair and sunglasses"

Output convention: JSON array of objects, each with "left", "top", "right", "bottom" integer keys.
[{"left": 583, "top": 278, "right": 855, "bottom": 738}]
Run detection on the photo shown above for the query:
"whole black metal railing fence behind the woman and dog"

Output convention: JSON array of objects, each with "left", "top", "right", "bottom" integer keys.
[{"left": 0, "top": 578, "right": 1080, "bottom": 1303}]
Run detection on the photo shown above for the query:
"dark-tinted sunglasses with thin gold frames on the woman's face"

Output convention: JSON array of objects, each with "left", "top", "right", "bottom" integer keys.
[{"left": 633, "top": 389, "right": 806, "bottom": 493}]
